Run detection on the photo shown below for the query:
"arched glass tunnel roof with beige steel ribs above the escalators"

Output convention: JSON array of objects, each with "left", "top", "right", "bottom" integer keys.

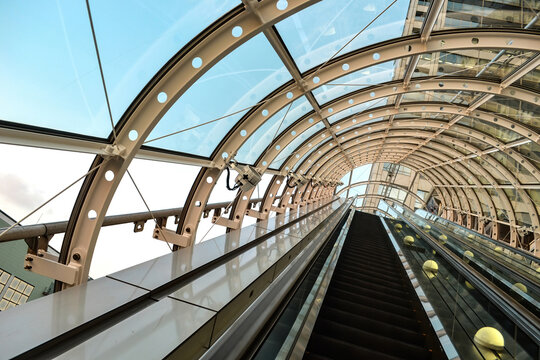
[{"left": 0, "top": 0, "right": 540, "bottom": 282}]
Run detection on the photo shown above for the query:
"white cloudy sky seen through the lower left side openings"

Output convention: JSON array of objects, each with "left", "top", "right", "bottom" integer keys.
[{"left": 0, "top": 144, "right": 271, "bottom": 278}]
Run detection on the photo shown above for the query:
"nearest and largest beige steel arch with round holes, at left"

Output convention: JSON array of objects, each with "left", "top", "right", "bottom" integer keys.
[{"left": 51, "top": 0, "right": 316, "bottom": 290}]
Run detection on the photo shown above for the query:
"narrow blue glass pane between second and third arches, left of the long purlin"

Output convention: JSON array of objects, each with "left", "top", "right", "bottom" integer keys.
[{"left": 235, "top": 96, "right": 313, "bottom": 165}]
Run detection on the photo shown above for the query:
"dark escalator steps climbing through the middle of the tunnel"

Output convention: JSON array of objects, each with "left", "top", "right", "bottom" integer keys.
[{"left": 304, "top": 212, "right": 442, "bottom": 359}]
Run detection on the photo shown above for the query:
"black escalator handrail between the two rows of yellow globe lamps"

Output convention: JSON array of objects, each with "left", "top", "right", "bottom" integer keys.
[{"left": 383, "top": 200, "right": 540, "bottom": 346}]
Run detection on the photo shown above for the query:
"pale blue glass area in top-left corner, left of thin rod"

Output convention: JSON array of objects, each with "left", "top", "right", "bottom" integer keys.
[{"left": 0, "top": 1, "right": 112, "bottom": 137}]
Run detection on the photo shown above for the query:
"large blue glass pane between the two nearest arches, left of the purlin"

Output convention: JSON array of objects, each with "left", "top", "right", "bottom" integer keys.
[{"left": 149, "top": 34, "right": 291, "bottom": 157}]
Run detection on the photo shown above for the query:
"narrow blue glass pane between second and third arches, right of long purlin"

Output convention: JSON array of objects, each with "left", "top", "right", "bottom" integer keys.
[{"left": 312, "top": 61, "right": 396, "bottom": 104}]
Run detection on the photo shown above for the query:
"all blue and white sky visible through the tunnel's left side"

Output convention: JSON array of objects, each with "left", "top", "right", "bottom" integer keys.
[{"left": 0, "top": 0, "right": 408, "bottom": 278}]
